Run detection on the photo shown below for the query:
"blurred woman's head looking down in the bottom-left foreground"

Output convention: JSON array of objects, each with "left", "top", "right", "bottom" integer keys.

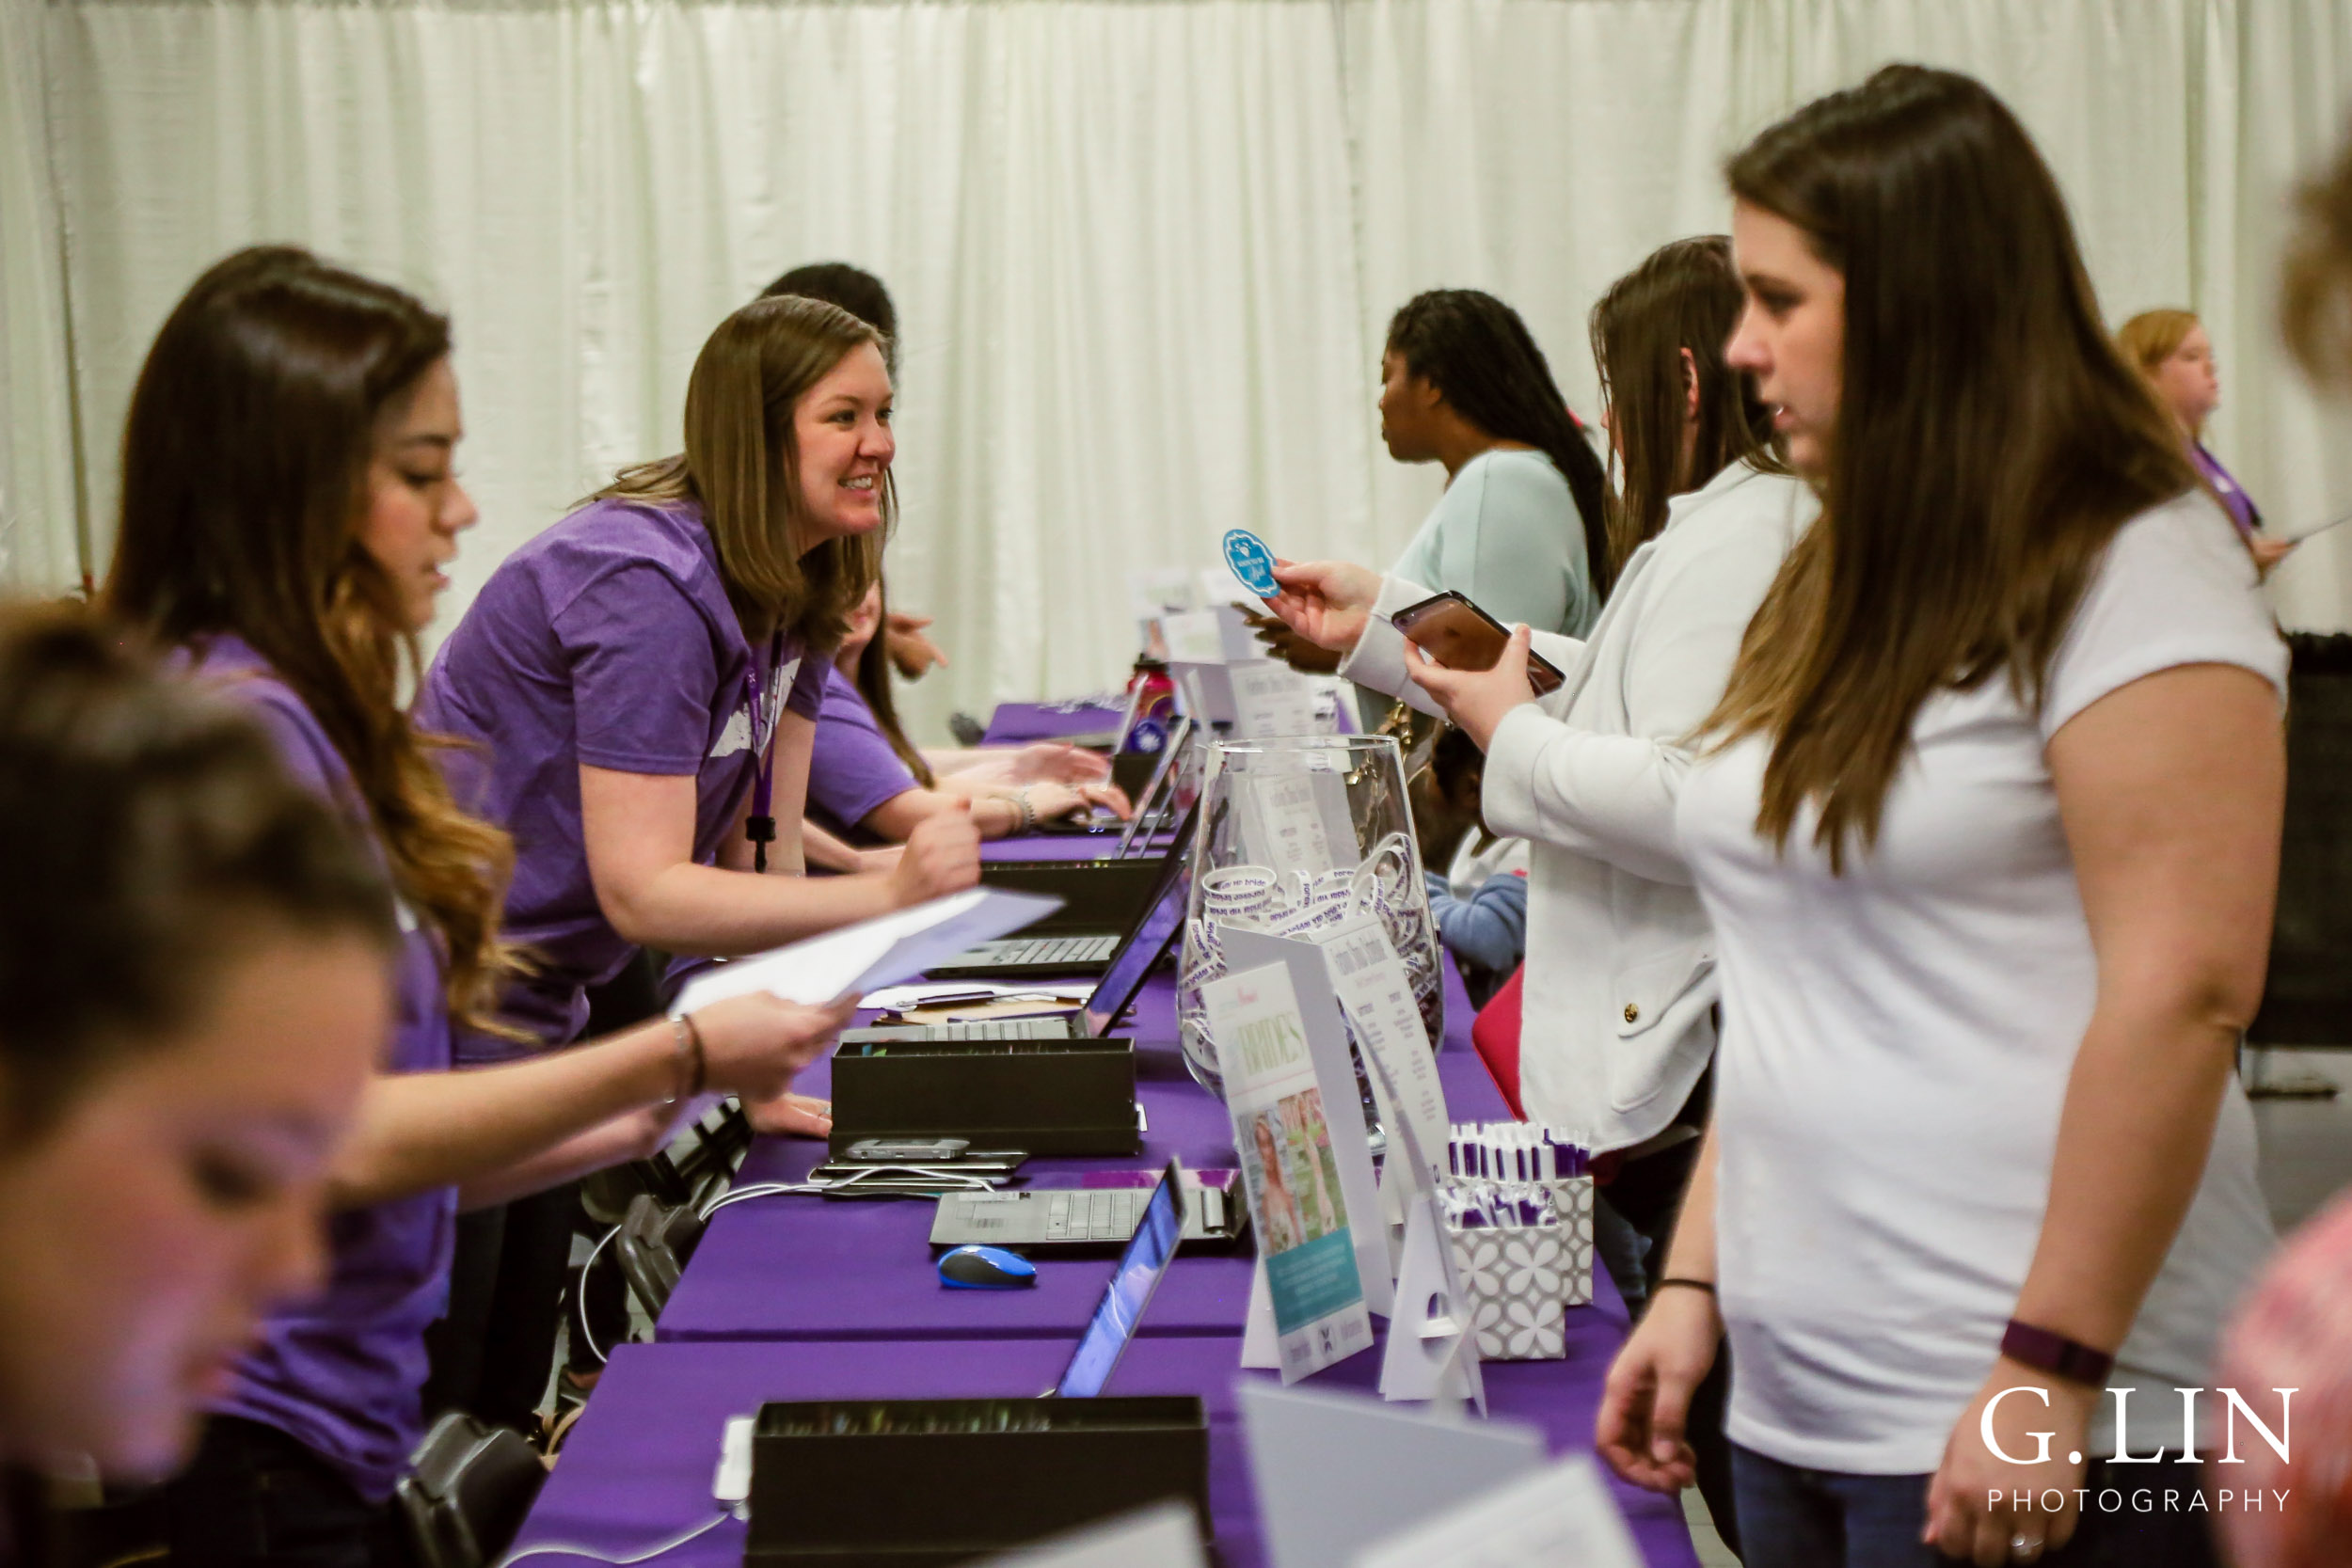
[{"left": 0, "top": 607, "right": 393, "bottom": 1563}]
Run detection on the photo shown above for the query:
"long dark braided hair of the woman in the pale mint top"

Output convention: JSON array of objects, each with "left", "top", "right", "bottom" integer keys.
[{"left": 1388, "top": 289, "right": 1616, "bottom": 599}]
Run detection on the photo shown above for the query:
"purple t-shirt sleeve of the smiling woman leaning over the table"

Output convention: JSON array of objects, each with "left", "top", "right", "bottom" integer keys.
[{"left": 553, "top": 564, "right": 718, "bottom": 776}]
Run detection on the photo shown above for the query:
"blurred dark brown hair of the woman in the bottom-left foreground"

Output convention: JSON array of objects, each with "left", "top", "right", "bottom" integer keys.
[{"left": 0, "top": 604, "right": 395, "bottom": 1138}]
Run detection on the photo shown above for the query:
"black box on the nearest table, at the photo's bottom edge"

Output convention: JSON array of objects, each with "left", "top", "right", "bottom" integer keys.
[{"left": 743, "top": 1397, "right": 1209, "bottom": 1568}]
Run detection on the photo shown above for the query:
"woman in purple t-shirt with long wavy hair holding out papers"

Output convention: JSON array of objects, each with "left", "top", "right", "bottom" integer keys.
[{"left": 106, "top": 246, "right": 847, "bottom": 1568}]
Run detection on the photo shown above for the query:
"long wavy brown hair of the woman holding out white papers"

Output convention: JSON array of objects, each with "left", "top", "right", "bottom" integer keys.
[{"left": 102, "top": 245, "right": 517, "bottom": 1030}]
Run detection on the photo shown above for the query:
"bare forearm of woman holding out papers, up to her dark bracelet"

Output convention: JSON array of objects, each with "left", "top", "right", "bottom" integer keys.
[{"left": 329, "top": 1018, "right": 682, "bottom": 1209}]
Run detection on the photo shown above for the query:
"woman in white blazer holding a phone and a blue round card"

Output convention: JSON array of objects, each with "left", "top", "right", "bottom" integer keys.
[{"left": 1275, "top": 235, "right": 1819, "bottom": 1540}]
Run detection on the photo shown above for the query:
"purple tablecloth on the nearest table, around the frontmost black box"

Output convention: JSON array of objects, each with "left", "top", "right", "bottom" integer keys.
[{"left": 517, "top": 1335, "right": 1698, "bottom": 1568}]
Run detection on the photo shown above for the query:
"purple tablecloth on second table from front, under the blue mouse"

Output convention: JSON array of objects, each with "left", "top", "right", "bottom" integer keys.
[{"left": 657, "top": 969, "right": 1477, "bottom": 1340}]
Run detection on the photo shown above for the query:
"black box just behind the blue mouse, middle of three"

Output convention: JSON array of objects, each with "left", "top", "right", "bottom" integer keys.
[{"left": 831, "top": 1037, "right": 1141, "bottom": 1154}]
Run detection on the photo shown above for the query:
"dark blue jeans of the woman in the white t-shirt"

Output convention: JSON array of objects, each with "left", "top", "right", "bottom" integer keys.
[{"left": 1731, "top": 1444, "right": 2220, "bottom": 1568}]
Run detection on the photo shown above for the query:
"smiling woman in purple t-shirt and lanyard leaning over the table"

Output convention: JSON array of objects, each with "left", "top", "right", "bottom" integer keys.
[{"left": 417, "top": 296, "right": 978, "bottom": 1420}]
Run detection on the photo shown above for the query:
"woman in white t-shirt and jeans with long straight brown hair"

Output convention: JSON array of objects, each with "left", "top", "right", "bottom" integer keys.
[{"left": 1597, "top": 66, "right": 2286, "bottom": 1568}]
